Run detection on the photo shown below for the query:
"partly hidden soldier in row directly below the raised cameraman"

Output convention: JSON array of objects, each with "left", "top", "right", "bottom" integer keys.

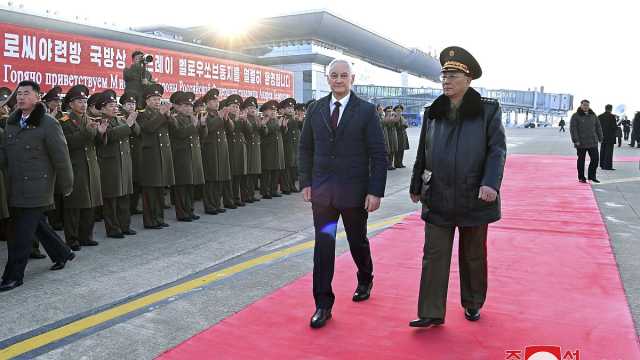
[{"left": 118, "top": 91, "right": 142, "bottom": 215}]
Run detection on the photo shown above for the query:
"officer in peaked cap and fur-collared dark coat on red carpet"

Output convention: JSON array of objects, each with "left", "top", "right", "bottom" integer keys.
[{"left": 409, "top": 46, "right": 507, "bottom": 327}]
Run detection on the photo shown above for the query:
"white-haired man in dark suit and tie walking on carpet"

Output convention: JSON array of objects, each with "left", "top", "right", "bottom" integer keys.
[{"left": 298, "top": 59, "right": 387, "bottom": 328}]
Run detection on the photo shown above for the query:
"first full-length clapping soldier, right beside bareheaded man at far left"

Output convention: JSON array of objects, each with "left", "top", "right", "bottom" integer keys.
[{"left": 60, "top": 85, "right": 106, "bottom": 251}]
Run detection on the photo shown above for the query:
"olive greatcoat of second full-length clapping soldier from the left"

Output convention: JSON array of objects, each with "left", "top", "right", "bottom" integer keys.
[{"left": 98, "top": 117, "right": 140, "bottom": 199}]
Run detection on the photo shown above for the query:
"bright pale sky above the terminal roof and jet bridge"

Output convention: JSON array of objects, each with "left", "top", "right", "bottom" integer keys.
[{"left": 13, "top": 0, "right": 640, "bottom": 116}]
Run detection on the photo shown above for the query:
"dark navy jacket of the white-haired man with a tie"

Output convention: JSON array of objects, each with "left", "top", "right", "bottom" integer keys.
[{"left": 298, "top": 92, "right": 387, "bottom": 208}]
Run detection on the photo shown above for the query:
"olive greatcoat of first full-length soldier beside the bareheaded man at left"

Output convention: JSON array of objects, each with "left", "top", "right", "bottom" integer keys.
[{"left": 60, "top": 112, "right": 102, "bottom": 209}]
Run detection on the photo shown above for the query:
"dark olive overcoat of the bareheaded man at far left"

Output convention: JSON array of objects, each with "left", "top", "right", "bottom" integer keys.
[{"left": 0, "top": 104, "right": 73, "bottom": 208}]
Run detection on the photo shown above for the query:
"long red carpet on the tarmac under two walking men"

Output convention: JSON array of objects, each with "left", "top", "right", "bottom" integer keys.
[{"left": 160, "top": 155, "right": 640, "bottom": 360}]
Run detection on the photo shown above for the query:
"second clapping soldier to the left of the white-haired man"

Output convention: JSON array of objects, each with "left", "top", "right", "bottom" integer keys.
[{"left": 260, "top": 100, "right": 285, "bottom": 199}]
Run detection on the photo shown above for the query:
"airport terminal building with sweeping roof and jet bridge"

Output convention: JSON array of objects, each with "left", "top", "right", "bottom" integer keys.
[{"left": 0, "top": 7, "right": 573, "bottom": 124}]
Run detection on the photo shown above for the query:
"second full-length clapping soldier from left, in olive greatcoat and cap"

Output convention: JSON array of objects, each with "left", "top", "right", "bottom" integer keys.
[{"left": 96, "top": 90, "right": 140, "bottom": 239}]
